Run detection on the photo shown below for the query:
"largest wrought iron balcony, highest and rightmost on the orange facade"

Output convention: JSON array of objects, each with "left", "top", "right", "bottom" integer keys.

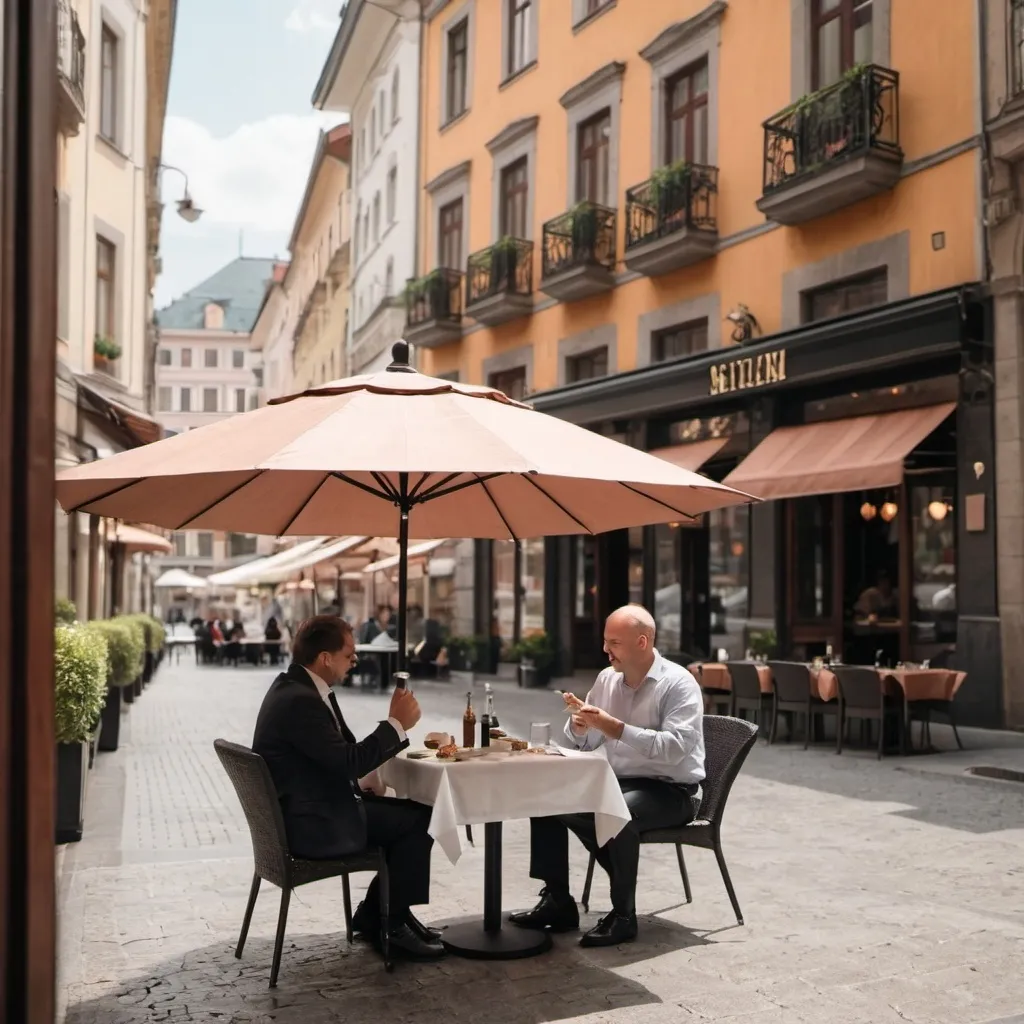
[{"left": 758, "top": 65, "right": 903, "bottom": 224}]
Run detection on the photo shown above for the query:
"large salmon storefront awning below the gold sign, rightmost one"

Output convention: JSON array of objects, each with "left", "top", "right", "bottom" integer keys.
[{"left": 723, "top": 401, "right": 956, "bottom": 500}]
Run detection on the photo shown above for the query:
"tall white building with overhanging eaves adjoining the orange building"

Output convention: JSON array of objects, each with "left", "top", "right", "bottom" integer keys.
[{"left": 313, "top": 0, "right": 420, "bottom": 374}]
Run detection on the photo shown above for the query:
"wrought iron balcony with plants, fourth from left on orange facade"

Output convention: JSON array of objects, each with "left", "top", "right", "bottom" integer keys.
[{"left": 626, "top": 163, "right": 718, "bottom": 278}]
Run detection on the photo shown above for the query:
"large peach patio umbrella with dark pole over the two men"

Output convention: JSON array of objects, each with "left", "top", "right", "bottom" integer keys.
[{"left": 56, "top": 341, "right": 756, "bottom": 669}]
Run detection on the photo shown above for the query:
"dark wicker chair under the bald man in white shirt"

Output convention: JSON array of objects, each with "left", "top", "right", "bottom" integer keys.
[{"left": 583, "top": 715, "right": 758, "bottom": 925}]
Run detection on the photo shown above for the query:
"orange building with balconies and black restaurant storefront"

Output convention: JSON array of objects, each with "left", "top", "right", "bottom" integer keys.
[{"left": 407, "top": 0, "right": 1007, "bottom": 723}]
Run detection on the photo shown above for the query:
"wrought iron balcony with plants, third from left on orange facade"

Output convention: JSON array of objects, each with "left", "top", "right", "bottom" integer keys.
[{"left": 541, "top": 203, "right": 615, "bottom": 302}]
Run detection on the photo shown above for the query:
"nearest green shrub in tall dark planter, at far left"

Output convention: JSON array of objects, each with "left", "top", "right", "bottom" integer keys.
[{"left": 53, "top": 626, "right": 108, "bottom": 843}]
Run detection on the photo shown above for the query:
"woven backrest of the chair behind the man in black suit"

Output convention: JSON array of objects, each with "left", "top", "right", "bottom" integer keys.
[{"left": 213, "top": 739, "right": 291, "bottom": 887}]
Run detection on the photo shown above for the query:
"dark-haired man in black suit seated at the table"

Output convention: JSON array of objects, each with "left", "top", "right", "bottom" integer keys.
[{"left": 253, "top": 615, "right": 444, "bottom": 959}]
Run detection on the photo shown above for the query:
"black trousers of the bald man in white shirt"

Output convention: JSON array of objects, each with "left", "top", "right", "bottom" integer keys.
[{"left": 529, "top": 778, "right": 696, "bottom": 914}]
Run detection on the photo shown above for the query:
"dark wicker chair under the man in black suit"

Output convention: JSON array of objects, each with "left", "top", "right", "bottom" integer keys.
[{"left": 213, "top": 739, "right": 393, "bottom": 988}]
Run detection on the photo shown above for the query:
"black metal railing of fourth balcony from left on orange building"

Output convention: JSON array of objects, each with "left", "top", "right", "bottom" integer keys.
[{"left": 626, "top": 164, "right": 718, "bottom": 249}]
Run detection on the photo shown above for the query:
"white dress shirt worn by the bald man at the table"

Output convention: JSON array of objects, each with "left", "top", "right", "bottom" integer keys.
[{"left": 565, "top": 648, "right": 705, "bottom": 783}]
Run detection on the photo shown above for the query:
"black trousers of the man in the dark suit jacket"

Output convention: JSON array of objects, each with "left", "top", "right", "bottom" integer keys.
[{"left": 362, "top": 794, "right": 434, "bottom": 923}]
